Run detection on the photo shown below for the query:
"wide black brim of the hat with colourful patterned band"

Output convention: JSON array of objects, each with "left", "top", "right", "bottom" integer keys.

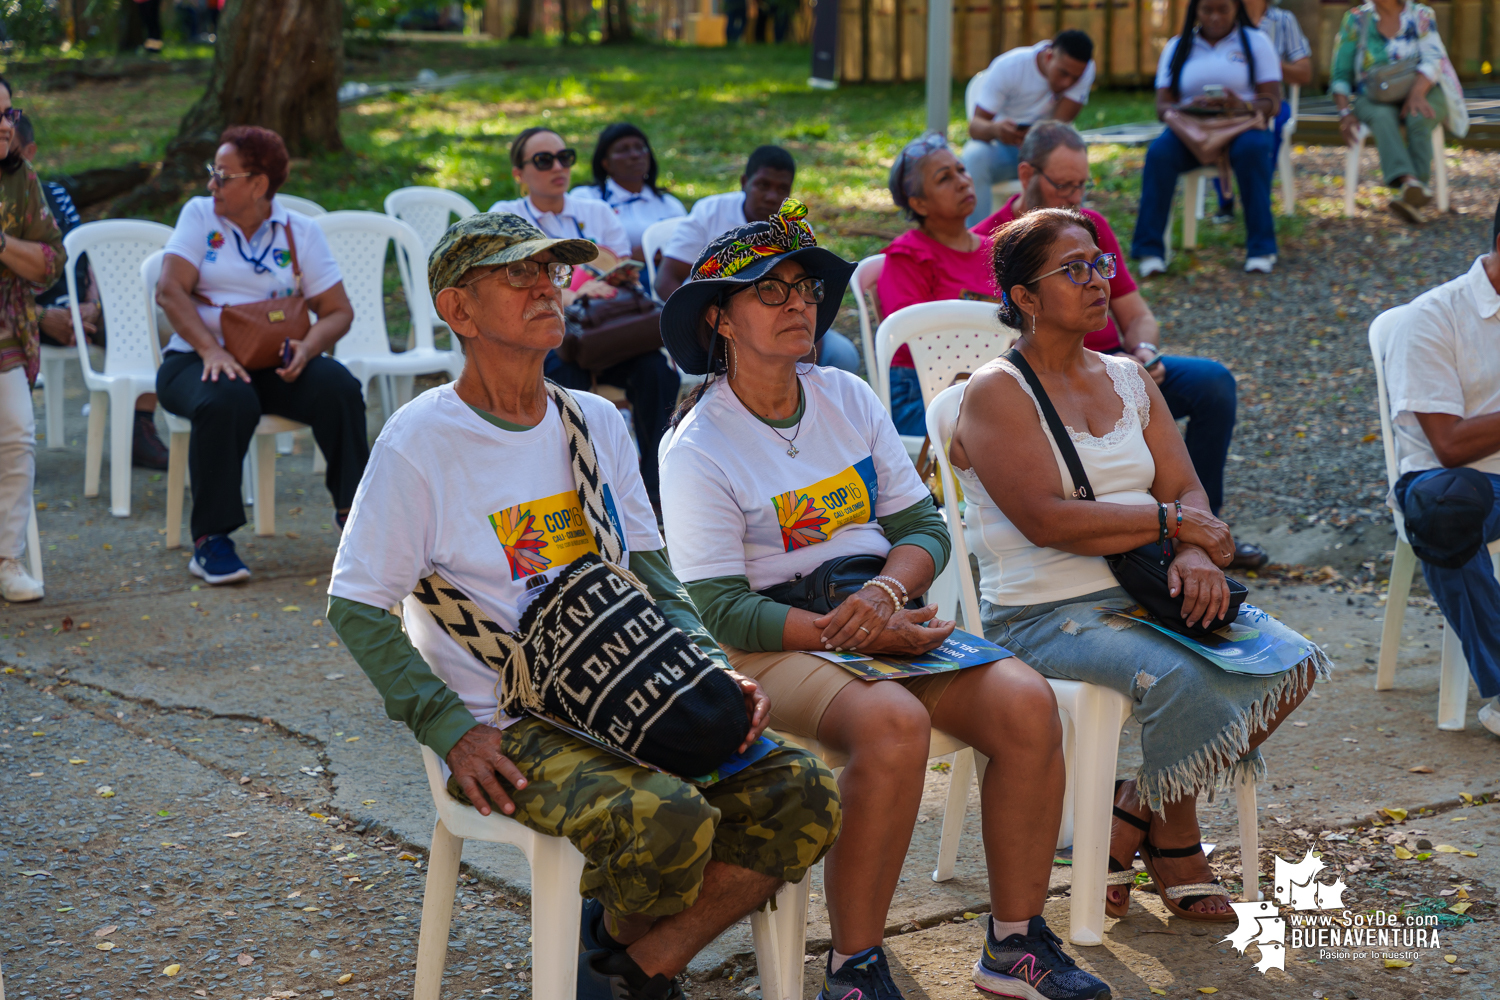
[{"left": 662, "top": 246, "right": 855, "bottom": 375}]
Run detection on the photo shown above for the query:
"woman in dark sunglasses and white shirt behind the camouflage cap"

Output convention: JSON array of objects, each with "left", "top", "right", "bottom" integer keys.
[{"left": 489, "top": 127, "right": 630, "bottom": 259}]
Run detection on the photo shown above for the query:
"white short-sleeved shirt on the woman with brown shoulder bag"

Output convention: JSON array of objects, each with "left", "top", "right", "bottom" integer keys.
[{"left": 167, "top": 196, "right": 344, "bottom": 351}]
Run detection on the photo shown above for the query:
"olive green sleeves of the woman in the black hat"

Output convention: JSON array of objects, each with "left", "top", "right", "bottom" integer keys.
[{"left": 687, "top": 496, "right": 953, "bottom": 652}]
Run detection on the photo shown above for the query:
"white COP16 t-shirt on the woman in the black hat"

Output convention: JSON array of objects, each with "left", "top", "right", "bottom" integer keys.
[{"left": 662, "top": 367, "right": 929, "bottom": 591}]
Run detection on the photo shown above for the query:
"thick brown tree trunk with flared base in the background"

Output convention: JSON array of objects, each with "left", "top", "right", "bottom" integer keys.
[{"left": 116, "top": 0, "right": 344, "bottom": 214}]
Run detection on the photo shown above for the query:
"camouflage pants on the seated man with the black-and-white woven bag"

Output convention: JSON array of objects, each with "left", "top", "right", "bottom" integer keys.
[{"left": 449, "top": 718, "right": 842, "bottom": 918}]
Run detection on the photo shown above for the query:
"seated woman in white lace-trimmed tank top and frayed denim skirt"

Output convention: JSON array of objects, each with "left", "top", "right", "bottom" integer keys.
[{"left": 950, "top": 208, "right": 1329, "bottom": 922}]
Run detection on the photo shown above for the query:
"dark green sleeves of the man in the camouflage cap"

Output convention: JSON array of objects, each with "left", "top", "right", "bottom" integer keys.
[{"left": 329, "top": 549, "right": 729, "bottom": 759}]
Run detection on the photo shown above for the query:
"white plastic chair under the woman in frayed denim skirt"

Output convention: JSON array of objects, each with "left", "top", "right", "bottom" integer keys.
[{"left": 927, "top": 385, "right": 1260, "bottom": 946}]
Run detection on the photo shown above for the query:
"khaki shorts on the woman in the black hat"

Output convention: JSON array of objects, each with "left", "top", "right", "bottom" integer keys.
[{"left": 725, "top": 648, "right": 959, "bottom": 739}]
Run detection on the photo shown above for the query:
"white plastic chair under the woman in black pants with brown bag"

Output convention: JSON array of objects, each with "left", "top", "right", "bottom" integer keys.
[{"left": 141, "top": 250, "right": 316, "bottom": 549}]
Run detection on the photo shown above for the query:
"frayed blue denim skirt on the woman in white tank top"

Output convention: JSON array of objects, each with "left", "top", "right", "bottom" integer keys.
[{"left": 980, "top": 586, "right": 1329, "bottom": 811}]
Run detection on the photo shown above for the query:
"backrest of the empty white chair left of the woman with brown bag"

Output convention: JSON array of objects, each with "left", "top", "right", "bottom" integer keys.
[{"left": 63, "top": 219, "right": 173, "bottom": 375}]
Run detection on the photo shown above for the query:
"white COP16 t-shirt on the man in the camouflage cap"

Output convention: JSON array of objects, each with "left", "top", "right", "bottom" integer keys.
[{"left": 329, "top": 382, "right": 662, "bottom": 723}]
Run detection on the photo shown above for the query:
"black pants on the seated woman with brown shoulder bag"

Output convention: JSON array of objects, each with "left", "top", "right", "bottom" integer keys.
[{"left": 156, "top": 351, "right": 371, "bottom": 538}]
